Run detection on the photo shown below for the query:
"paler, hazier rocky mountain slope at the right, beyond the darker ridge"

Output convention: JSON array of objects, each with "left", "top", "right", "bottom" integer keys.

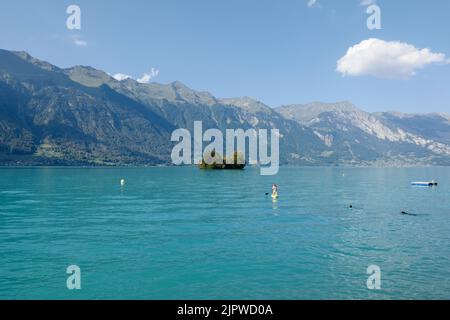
[{"left": 276, "top": 102, "right": 450, "bottom": 165}]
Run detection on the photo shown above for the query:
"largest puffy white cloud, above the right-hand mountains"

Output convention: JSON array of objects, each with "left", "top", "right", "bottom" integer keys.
[{"left": 336, "top": 38, "right": 450, "bottom": 79}]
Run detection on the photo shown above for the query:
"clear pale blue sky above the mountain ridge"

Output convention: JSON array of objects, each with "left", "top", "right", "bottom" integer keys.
[{"left": 0, "top": 0, "right": 450, "bottom": 113}]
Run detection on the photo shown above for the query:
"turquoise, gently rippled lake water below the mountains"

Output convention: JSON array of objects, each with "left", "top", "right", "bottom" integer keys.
[{"left": 0, "top": 168, "right": 450, "bottom": 299}]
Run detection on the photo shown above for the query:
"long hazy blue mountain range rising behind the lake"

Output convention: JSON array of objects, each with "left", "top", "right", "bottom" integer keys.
[{"left": 0, "top": 50, "right": 450, "bottom": 165}]
